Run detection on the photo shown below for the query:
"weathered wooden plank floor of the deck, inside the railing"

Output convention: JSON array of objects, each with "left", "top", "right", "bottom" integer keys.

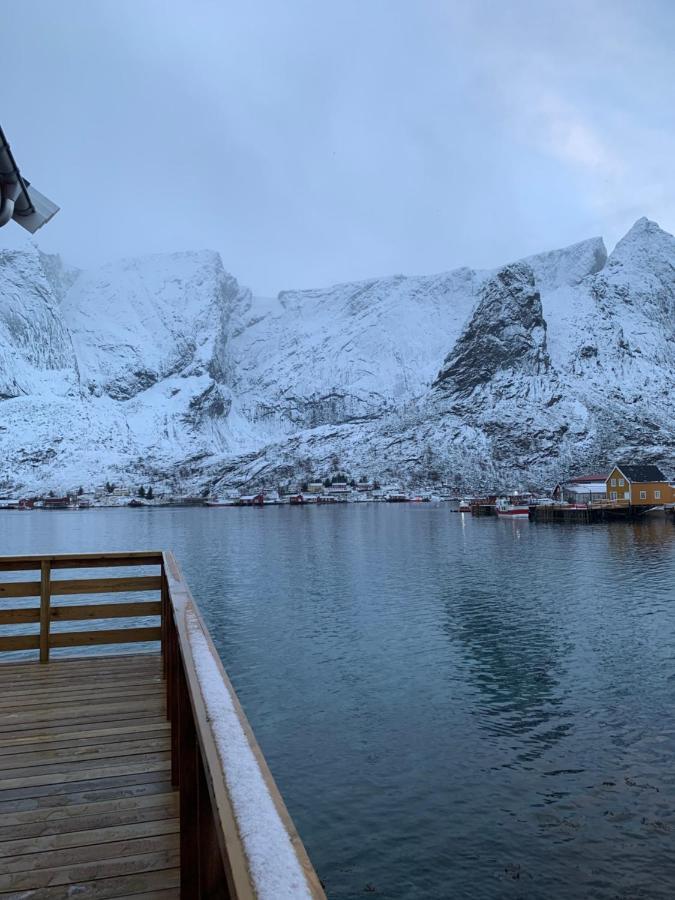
[{"left": 0, "top": 653, "right": 180, "bottom": 900}]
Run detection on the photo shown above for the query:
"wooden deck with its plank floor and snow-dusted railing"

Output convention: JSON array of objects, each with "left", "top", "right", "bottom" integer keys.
[{"left": 0, "top": 552, "right": 325, "bottom": 900}]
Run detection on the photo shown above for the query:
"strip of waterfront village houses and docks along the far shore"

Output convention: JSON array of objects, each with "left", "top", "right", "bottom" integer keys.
[{"left": 0, "top": 461, "right": 675, "bottom": 522}]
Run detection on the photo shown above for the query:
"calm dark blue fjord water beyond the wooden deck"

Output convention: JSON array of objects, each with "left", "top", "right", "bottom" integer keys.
[{"left": 0, "top": 504, "right": 675, "bottom": 900}]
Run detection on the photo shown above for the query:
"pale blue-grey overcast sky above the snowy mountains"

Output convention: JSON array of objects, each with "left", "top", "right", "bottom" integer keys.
[{"left": 5, "top": 0, "right": 675, "bottom": 294}]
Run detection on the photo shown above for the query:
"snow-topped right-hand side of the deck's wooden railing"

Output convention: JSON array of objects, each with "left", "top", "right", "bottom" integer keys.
[{"left": 163, "top": 553, "right": 325, "bottom": 900}]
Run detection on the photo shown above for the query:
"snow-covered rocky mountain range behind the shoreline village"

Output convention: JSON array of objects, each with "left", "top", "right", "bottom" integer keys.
[{"left": 0, "top": 219, "right": 675, "bottom": 492}]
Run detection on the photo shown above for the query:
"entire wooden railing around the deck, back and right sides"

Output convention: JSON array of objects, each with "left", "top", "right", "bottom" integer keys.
[{"left": 0, "top": 551, "right": 325, "bottom": 900}]
